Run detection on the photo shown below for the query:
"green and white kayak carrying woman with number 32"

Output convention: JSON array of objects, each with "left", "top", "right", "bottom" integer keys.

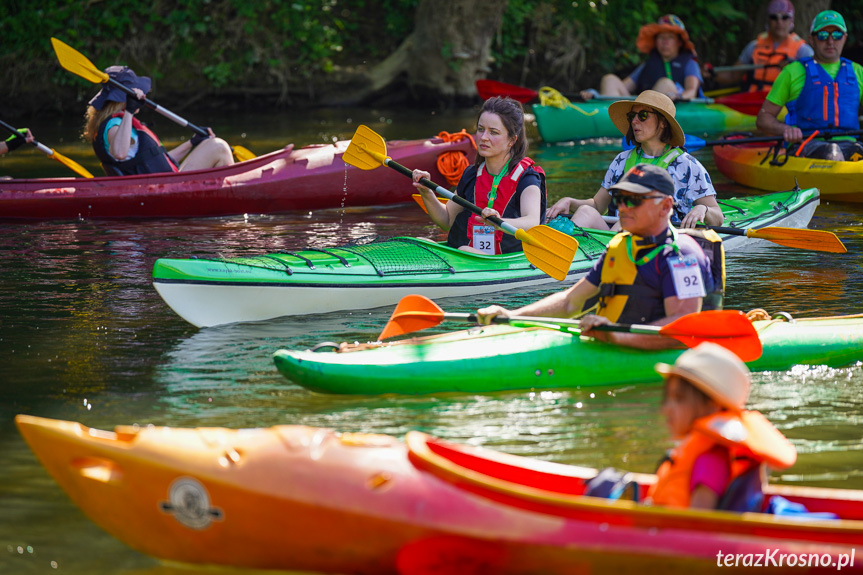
[{"left": 153, "top": 188, "right": 819, "bottom": 327}]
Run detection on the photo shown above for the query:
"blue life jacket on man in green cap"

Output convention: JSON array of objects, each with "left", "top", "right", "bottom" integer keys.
[{"left": 785, "top": 58, "right": 860, "bottom": 132}]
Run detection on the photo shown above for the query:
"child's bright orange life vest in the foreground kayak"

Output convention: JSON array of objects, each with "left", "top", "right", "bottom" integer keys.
[{"left": 647, "top": 411, "right": 797, "bottom": 508}]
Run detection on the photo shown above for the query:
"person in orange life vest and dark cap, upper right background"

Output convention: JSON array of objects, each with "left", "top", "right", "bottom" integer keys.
[{"left": 704, "top": 0, "right": 814, "bottom": 92}]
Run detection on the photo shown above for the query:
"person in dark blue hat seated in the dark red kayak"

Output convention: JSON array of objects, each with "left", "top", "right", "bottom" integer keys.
[{"left": 84, "top": 66, "right": 234, "bottom": 176}]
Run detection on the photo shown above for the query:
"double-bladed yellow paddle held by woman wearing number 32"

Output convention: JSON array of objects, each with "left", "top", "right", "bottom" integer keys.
[{"left": 342, "top": 126, "right": 578, "bottom": 280}]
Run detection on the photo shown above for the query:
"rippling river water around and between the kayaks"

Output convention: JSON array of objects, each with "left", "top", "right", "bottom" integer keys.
[{"left": 0, "top": 110, "right": 863, "bottom": 575}]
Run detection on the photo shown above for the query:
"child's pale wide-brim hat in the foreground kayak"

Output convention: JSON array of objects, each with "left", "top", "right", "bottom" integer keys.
[{"left": 654, "top": 342, "right": 752, "bottom": 411}]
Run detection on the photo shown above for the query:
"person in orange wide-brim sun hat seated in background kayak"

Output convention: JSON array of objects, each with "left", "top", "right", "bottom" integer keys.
[{"left": 581, "top": 14, "right": 703, "bottom": 100}]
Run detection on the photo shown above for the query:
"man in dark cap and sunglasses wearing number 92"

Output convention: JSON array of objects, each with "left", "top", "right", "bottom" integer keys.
[{"left": 477, "top": 164, "right": 722, "bottom": 349}]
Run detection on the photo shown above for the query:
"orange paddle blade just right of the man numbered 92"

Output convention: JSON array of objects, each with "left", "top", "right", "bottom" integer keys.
[{"left": 659, "top": 310, "right": 762, "bottom": 361}]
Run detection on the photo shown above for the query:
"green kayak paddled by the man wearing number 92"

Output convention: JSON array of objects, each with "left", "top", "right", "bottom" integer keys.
[{"left": 274, "top": 314, "right": 863, "bottom": 394}]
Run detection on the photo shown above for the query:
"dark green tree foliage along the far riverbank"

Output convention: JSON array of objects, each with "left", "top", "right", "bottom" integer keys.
[{"left": 0, "top": 0, "right": 863, "bottom": 113}]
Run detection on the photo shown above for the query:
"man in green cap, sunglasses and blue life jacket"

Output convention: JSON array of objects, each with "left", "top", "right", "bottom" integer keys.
[{"left": 756, "top": 10, "right": 863, "bottom": 161}]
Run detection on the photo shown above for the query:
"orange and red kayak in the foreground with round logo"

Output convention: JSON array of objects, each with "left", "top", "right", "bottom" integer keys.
[{"left": 16, "top": 415, "right": 863, "bottom": 574}]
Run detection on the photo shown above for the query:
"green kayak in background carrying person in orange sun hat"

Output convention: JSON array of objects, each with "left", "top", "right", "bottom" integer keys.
[{"left": 533, "top": 100, "right": 755, "bottom": 143}]
